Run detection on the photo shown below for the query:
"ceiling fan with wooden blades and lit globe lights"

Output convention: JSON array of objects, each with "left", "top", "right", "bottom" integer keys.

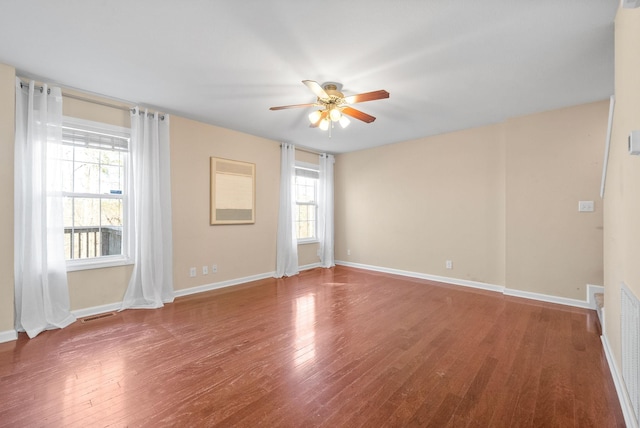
[{"left": 269, "top": 80, "right": 389, "bottom": 131}]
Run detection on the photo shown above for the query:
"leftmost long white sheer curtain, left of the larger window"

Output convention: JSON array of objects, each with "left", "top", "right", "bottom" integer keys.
[{"left": 14, "top": 79, "right": 75, "bottom": 338}]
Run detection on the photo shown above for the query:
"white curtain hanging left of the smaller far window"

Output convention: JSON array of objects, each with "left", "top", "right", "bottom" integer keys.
[{"left": 276, "top": 144, "right": 298, "bottom": 278}]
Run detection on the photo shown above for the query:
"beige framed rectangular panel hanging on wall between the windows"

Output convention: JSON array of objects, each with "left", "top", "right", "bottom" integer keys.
[{"left": 211, "top": 157, "right": 256, "bottom": 225}]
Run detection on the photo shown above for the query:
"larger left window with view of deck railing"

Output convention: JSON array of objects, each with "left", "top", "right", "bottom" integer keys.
[{"left": 62, "top": 118, "right": 130, "bottom": 270}]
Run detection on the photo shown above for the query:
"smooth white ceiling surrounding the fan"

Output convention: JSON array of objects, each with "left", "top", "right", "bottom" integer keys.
[{"left": 0, "top": 0, "right": 618, "bottom": 153}]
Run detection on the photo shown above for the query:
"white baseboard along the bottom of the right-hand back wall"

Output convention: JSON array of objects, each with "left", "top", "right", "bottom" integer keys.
[{"left": 336, "top": 260, "right": 591, "bottom": 309}]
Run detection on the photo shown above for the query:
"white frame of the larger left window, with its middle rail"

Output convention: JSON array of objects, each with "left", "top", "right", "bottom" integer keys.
[{"left": 62, "top": 116, "right": 133, "bottom": 272}]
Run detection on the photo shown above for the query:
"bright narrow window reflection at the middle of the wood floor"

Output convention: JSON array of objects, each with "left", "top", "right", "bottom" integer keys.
[{"left": 293, "top": 294, "right": 316, "bottom": 367}]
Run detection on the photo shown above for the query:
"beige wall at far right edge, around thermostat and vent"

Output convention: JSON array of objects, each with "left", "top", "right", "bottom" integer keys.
[{"left": 604, "top": 9, "right": 640, "bottom": 369}]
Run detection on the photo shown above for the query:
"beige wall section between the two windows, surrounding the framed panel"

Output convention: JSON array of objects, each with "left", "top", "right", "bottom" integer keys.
[{"left": 171, "top": 116, "right": 280, "bottom": 290}]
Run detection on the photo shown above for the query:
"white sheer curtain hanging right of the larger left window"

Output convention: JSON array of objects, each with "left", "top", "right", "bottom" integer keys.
[{"left": 121, "top": 108, "right": 174, "bottom": 310}]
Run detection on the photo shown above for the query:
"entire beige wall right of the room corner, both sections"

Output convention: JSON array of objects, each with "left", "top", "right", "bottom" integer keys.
[{"left": 336, "top": 102, "right": 608, "bottom": 300}]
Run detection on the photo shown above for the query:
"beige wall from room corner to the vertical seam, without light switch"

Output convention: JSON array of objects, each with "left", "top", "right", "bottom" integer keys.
[{"left": 335, "top": 126, "right": 504, "bottom": 284}]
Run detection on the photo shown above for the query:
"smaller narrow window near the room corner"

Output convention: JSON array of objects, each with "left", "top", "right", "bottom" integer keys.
[{"left": 295, "top": 166, "right": 319, "bottom": 242}]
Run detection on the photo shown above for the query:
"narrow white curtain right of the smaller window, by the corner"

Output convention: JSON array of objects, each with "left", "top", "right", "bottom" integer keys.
[{"left": 318, "top": 154, "right": 335, "bottom": 268}]
